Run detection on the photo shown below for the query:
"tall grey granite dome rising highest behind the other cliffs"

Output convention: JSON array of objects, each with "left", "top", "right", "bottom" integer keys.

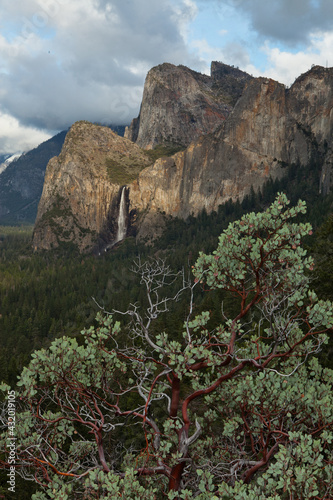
[{"left": 125, "top": 63, "right": 251, "bottom": 149}]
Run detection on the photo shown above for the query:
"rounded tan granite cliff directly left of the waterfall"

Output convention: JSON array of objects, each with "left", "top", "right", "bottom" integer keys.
[{"left": 33, "top": 122, "right": 151, "bottom": 251}]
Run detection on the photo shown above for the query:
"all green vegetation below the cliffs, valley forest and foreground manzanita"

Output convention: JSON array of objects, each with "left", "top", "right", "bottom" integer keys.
[{"left": 0, "top": 185, "right": 333, "bottom": 500}]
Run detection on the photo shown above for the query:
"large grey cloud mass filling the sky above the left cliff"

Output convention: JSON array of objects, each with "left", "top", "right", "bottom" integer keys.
[{"left": 0, "top": 0, "right": 197, "bottom": 130}]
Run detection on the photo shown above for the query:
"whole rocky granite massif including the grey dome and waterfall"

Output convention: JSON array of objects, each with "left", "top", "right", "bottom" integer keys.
[{"left": 34, "top": 63, "right": 333, "bottom": 251}]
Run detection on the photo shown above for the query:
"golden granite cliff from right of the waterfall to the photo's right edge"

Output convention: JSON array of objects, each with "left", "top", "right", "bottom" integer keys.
[{"left": 130, "top": 68, "right": 333, "bottom": 218}]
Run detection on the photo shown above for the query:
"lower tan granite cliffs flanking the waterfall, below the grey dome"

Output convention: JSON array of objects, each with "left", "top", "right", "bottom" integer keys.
[{"left": 34, "top": 65, "right": 333, "bottom": 251}]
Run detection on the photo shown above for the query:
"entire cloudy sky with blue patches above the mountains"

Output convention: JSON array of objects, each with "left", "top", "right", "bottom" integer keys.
[{"left": 0, "top": 0, "right": 333, "bottom": 154}]
